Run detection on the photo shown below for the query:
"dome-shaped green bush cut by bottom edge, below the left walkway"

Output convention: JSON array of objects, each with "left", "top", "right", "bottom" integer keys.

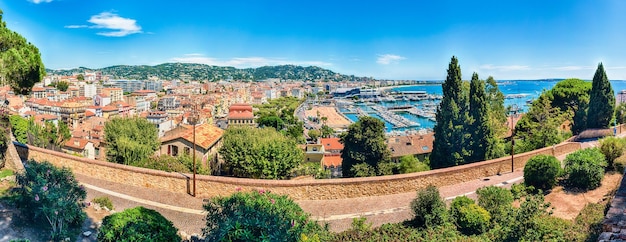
[{"left": 98, "top": 207, "right": 181, "bottom": 242}]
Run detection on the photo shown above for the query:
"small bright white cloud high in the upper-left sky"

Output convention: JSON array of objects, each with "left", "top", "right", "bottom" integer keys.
[{"left": 65, "top": 12, "right": 142, "bottom": 37}]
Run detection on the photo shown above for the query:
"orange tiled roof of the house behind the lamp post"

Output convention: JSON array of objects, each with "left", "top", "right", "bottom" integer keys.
[{"left": 161, "top": 123, "right": 224, "bottom": 149}]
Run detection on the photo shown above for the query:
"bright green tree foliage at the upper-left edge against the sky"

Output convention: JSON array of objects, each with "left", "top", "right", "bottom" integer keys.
[{"left": 0, "top": 12, "right": 46, "bottom": 94}]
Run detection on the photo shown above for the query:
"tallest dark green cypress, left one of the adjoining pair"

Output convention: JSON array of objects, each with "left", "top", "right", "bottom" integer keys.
[{"left": 430, "top": 56, "right": 467, "bottom": 168}]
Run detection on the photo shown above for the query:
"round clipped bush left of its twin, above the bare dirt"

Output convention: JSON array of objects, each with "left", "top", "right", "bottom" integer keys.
[{"left": 524, "top": 155, "right": 562, "bottom": 190}]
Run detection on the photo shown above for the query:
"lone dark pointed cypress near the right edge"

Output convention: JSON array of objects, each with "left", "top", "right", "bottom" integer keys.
[{"left": 587, "top": 63, "right": 615, "bottom": 128}]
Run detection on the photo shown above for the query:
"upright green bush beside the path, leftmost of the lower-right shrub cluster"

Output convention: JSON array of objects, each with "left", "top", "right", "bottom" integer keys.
[{"left": 411, "top": 185, "right": 448, "bottom": 227}]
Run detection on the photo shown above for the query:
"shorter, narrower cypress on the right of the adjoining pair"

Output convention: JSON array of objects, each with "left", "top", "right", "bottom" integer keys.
[{"left": 465, "top": 73, "right": 495, "bottom": 163}]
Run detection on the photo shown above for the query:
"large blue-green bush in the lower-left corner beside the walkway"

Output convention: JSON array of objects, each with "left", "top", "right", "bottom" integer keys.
[{"left": 14, "top": 160, "right": 87, "bottom": 241}]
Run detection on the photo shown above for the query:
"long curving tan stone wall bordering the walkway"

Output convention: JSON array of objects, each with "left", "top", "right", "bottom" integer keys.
[{"left": 18, "top": 142, "right": 581, "bottom": 200}]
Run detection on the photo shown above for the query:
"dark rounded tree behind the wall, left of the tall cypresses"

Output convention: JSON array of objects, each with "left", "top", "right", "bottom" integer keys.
[{"left": 340, "top": 116, "right": 391, "bottom": 177}]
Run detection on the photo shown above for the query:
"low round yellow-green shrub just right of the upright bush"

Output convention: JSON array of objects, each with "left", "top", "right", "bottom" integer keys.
[{"left": 457, "top": 203, "right": 491, "bottom": 235}]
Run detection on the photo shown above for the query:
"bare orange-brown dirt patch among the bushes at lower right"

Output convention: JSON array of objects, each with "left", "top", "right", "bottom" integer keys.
[{"left": 545, "top": 173, "right": 622, "bottom": 220}]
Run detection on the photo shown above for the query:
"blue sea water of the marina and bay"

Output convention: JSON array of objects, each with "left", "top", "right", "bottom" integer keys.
[{"left": 339, "top": 80, "right": 626, "bottom": 133}]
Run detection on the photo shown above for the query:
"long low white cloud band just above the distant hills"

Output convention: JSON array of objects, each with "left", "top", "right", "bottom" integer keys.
[{"left": 170, "top": 53, "right": 332, "bottom": 68}]
